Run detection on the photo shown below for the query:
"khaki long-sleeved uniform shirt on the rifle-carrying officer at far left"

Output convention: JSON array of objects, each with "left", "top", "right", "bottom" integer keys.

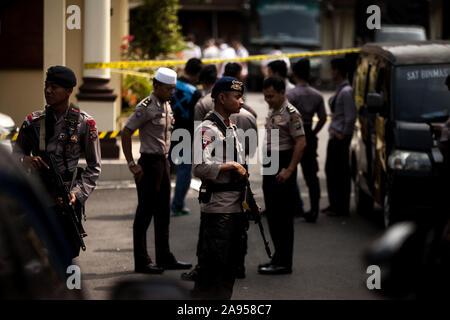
[{"left": 14, "top": 105, "right": 101, "bottom": 204}]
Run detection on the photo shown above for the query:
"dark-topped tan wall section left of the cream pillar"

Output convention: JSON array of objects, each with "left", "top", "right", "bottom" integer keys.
[{"left": 0, "top": 0, "right": 44, "bottom": 126}]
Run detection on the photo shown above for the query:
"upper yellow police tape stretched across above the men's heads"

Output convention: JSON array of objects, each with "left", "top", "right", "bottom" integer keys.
[{"left": 84, "top": 48, "right": 360, "bottom": 69}]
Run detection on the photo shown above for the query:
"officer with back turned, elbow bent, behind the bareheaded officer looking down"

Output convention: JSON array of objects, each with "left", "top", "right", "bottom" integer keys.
[{"left": 286, "top": 59, "right": 327, "bottom": 222}]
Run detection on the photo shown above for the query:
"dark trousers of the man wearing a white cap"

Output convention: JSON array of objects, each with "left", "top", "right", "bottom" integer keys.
[{"left": 133, "top": 153, "right": 175, "bottom": 266}]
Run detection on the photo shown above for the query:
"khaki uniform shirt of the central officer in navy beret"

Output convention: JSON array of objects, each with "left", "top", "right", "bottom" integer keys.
[{"left": 193, "top": 112, "right": 244, "bottom": 213}]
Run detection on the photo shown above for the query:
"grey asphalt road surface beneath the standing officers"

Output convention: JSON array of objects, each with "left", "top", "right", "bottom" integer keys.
[{"left": 76, "top": 93, "right": 383, "bottom": 300}]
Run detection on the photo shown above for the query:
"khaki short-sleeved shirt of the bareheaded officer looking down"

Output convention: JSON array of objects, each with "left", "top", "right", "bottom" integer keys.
[{"left": 264, "top": 100, "right": 305, "bottom": 151}]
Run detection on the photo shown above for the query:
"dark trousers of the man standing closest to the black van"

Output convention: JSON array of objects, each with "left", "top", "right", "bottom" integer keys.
[{"left": 325, "top": 136, "right": 352, "bottom": 215}]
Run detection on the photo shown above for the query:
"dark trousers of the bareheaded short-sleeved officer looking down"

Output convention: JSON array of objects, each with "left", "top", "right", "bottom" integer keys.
[{"left": 263, "top": 150, "right": 297, "bottom": 268}]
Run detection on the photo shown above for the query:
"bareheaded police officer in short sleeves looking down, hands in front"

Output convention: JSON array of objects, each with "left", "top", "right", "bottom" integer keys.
[{"left": 258, "top": 78, "right": 306, "bottom": 274}]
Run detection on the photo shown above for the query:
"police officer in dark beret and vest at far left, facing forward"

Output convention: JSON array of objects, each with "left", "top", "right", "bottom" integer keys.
[{"left": 14, "top": 66, "right": 101, "bottom": 265}]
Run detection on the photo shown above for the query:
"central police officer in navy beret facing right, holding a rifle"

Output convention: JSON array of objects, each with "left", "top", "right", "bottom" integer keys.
[{"left": 193, "top": 77, "right": 248, "bottom": 299}]
